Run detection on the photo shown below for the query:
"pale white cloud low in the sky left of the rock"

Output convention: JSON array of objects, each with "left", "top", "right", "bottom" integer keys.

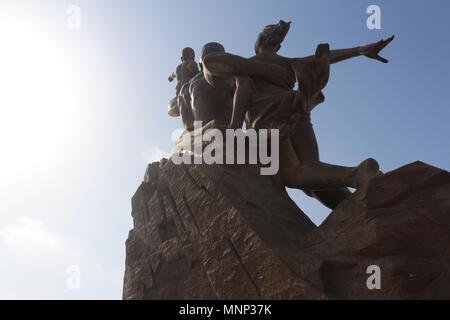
[{"left": 0, "top": 216, "right": 123, "bottom": 299}]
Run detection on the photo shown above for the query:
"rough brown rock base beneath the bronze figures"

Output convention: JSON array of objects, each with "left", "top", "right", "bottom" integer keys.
[{"left": 123, "top": 161, "right": 450, "bottom": 299}]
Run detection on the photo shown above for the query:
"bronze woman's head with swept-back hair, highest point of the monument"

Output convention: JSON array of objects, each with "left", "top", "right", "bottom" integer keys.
[{"left": 255, "top": 20, "right": 291, "bottom": 54}]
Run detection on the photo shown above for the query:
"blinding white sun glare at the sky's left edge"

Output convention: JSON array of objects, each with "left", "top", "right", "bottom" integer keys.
[{"left": 0, "top": 19, "right": 81, "bottom": 180}]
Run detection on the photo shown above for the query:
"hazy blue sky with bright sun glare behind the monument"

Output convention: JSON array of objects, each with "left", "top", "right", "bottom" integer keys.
[{"left": 0, "top": 0, "right": 450, "bottom": 299}]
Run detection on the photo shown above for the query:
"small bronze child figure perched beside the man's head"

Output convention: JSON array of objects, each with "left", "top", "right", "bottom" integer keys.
[{"left": 168, "top": 47, "right": 199, "bottom": 117}]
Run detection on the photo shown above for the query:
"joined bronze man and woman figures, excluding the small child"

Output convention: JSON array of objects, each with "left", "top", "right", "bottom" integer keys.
[{"left": 169, "top": 21, "right": 393, "bottom": 208}]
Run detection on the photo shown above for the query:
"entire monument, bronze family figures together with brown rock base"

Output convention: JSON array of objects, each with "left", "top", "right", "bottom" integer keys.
[{"left": 123, "top": 21, "right": 450, "bottom": 299}]
